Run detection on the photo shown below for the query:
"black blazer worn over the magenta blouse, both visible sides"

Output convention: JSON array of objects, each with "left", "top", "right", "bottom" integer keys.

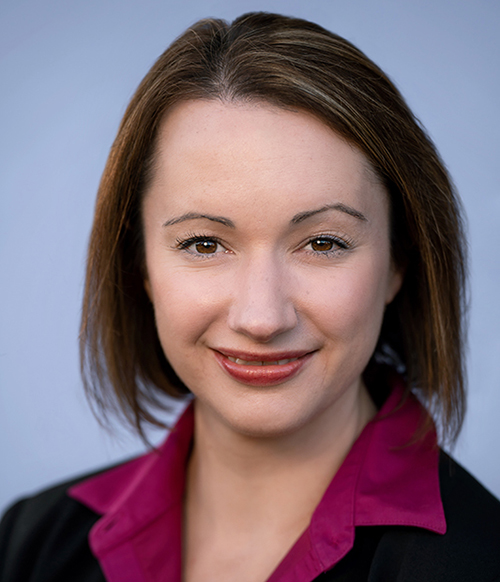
[{"left": 0, "top": 453, "right": 500, "bottom": 582}]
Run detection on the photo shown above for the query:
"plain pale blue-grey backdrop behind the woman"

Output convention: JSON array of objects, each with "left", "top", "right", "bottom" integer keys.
[{"left": 0, "top": 0, "right": 500, "bottom": 508}]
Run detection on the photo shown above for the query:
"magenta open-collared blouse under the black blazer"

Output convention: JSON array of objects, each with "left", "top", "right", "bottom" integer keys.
[{"left": 69, "top": 385, "right": 446, "bottom": 582}]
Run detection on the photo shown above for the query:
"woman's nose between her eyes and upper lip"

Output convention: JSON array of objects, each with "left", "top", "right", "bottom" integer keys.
[{"left": 228, "top": 257, "right": 298, "bottom": 343}]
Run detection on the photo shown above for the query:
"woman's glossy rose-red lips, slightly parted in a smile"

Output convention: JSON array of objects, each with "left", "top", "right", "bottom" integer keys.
[{"left": 214, "top": 350, "right": 313, "bottom": 386}]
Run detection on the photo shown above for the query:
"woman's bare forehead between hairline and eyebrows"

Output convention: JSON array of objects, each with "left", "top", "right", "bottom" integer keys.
[{"left": 145, "top": 100, "right": 386, "bottom": 220}]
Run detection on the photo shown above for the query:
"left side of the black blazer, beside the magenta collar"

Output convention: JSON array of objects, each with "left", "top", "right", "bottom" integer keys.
[{"left": 0, "top": 475, "right": 108, "bottom": 582}]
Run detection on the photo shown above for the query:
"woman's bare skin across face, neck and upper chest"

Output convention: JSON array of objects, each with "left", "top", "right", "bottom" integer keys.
[{"left": 143, "top": 101, "right": 402, "bottom": 582}]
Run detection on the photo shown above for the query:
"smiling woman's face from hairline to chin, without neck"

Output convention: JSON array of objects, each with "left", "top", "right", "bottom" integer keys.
[{"left": 143, "top": 101, "right": 401, "bottom": 436}]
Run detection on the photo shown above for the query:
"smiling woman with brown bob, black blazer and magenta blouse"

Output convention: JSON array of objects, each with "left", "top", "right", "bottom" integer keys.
[{"left": 0, "top": 13, "right": 500, "bottom": 582}]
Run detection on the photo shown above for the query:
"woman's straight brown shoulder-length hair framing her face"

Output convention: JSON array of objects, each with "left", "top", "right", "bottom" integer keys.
[{"left": 80, "top": 13, "right": 466, "bottom": 440}]
